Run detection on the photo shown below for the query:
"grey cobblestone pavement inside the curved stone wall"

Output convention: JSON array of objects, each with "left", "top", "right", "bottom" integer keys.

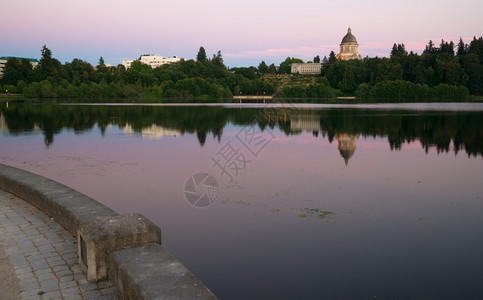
[{"left": 0, "top": 189, "right": 118, "bottom": 300}]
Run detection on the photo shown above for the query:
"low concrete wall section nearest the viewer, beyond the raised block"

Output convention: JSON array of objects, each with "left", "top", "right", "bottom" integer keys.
[{"left": 109, "top": 244, "right": 218, "bottom": 300}]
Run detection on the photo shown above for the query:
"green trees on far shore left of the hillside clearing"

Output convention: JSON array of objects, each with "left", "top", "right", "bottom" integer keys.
[{"left": 0, "top": 45, "right": 274, "bottom": 101}]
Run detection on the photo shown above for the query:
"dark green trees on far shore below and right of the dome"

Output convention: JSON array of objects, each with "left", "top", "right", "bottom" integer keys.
[{"left": 322, "top": 37, "right": 483, "bottom": 100}]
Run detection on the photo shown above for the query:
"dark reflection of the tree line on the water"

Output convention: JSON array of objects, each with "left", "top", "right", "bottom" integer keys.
[{"left": 1, "top": 104, "right": 483, "bottom": 159}]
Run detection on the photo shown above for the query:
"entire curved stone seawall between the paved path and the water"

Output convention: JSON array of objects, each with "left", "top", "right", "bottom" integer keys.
[{"left": 0, "top": 164, "right": 217, "bottom": 299}]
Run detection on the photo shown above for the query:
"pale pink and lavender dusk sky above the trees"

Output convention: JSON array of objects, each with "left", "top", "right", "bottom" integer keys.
[{"left": 0, "top": 0, "right": 483, "bottom": 67}]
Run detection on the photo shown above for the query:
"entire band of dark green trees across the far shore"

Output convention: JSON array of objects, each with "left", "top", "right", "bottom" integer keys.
[{"left": 0, "top": 37, "right": 483, "bottom": 101}]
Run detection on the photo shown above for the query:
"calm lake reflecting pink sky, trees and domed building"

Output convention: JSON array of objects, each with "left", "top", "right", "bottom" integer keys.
[{"left": 0, "top": 103, "right": 483, "bottom": 299}]
